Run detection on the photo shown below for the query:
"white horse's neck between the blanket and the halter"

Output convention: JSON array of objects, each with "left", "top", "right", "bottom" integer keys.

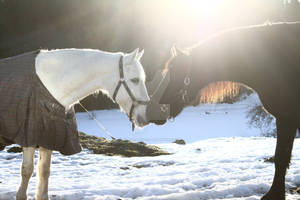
[{"left": 36, "top": 49, "right": 120, "bottom": 108}]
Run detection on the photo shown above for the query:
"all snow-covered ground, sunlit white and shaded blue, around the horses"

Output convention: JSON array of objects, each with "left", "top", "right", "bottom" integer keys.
[{"left": 0, "top": 96, "right": 300, "bottom": 200}]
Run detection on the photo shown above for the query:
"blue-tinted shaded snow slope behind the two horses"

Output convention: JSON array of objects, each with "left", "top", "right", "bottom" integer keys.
[{"left": 77, "top": 94, "right": 260, "bottom": 144}]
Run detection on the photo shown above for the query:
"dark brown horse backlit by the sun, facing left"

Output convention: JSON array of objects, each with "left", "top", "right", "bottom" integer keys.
[{"left": 154, "top": 23, "right": 300, "bottom": 200}]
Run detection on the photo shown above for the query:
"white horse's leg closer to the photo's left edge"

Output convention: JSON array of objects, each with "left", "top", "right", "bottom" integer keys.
[{"left": 16, "top": 147, "right": 35, "bottom": 200}]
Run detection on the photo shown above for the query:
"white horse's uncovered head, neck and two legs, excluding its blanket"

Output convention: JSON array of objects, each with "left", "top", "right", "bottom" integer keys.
[{"left": 16, "top": 49, "right": 149, "bottom": 200}]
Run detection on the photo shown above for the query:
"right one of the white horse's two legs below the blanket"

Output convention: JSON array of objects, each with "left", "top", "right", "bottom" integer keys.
[{"left": 36, "top": 147, "right": 52, "bottom": 200}]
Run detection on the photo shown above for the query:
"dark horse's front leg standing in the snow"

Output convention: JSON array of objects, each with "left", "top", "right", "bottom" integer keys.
[{"left": 262, "top": 119, "right": 296, "bottom": 200}]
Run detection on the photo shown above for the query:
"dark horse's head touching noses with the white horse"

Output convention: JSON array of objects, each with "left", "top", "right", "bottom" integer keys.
[{"left": 146, "top": 47, "right": 191, "bottom": 125}]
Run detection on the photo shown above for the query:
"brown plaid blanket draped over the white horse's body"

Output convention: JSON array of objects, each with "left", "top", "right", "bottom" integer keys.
[{"left": 0, "top": 51, "right": 81, "bottom": 155}]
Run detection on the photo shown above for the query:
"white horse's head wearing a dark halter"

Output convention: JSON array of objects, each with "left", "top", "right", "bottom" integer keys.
[{"left": 114, "top": 49, "right": 150, "bottom": 127}]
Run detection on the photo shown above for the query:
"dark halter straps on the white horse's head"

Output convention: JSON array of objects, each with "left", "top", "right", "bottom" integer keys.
[{"left": 113, "top": 56, "right": 148, "bottom": 131}]
